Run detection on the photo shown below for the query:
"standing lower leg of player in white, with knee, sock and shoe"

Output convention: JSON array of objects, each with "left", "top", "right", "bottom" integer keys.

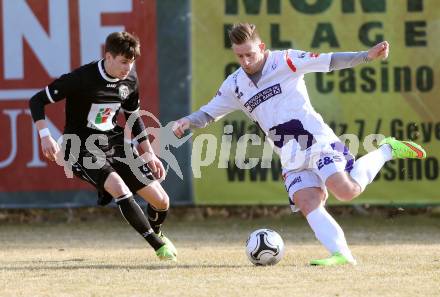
[{"left": 293, "top": 188, "right": 356, "bottom": 266}]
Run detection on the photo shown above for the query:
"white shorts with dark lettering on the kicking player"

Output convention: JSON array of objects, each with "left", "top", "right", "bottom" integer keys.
[{"left": 283, "top": 142, "right": 355, "bottom": 212}]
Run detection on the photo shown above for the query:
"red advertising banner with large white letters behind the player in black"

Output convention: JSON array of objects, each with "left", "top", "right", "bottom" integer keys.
[{"left": 0, "top": 0, "right": 159, "bottom": 193}]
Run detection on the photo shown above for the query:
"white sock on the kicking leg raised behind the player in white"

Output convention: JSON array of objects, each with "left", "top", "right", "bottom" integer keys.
[{"left": 350, "top": 144, "right": 393, "bottom": 192}]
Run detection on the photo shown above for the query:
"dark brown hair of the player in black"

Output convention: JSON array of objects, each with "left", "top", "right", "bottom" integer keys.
[{"left": 105, "top": 32, "right": 141, "bottom": 59}]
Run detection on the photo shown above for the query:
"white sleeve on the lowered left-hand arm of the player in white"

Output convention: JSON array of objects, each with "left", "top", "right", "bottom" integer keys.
[{"left": 200, "top": 79, "right": 243, "bottom": 121}]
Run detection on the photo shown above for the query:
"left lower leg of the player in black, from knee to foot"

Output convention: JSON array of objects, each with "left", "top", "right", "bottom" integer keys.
[{"left": 104, "top": 172, "right": 176, "bottom": 261}]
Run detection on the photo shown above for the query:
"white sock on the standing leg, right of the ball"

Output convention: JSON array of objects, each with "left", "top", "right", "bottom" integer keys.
[{"left": 306, "top": 206, "right": 356, "bottom": 262}]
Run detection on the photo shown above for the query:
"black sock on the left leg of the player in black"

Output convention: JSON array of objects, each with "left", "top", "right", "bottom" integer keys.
[{"left": 116, "top": 195, "right": 165, "bottom": 250}]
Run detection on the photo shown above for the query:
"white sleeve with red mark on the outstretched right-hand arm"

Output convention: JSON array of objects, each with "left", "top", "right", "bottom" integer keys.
[{"left": 285, "top": 50, "right": 332, "bottom": 74}]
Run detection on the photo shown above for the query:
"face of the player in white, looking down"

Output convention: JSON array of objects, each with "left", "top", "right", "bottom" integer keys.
[{"left": 232, "top": 40, "right": 266, "bottom": 74}]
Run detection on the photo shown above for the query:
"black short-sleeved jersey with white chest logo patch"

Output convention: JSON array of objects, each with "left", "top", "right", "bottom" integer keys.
[{"left": 45, "top": 60, "right": 139, "bottom": 140}]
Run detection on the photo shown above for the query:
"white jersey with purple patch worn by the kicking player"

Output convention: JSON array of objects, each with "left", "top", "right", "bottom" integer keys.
[{"left": 200, "top": 49, "right": 339, "bottom": 169}]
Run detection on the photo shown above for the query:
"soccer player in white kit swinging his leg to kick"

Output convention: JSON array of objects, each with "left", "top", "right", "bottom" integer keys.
[{"left": 173, "top": 23, "right": 426, "bottom": 265}]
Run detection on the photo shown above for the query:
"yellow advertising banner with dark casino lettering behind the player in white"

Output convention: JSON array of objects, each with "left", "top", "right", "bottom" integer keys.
[{"left": 191, "top": 0, "right": 440, "bottom": 204}]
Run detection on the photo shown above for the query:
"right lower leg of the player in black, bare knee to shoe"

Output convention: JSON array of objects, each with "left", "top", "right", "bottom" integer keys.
[{"left": 137, "top": 181, "right": 177, "bottom": 256}]
